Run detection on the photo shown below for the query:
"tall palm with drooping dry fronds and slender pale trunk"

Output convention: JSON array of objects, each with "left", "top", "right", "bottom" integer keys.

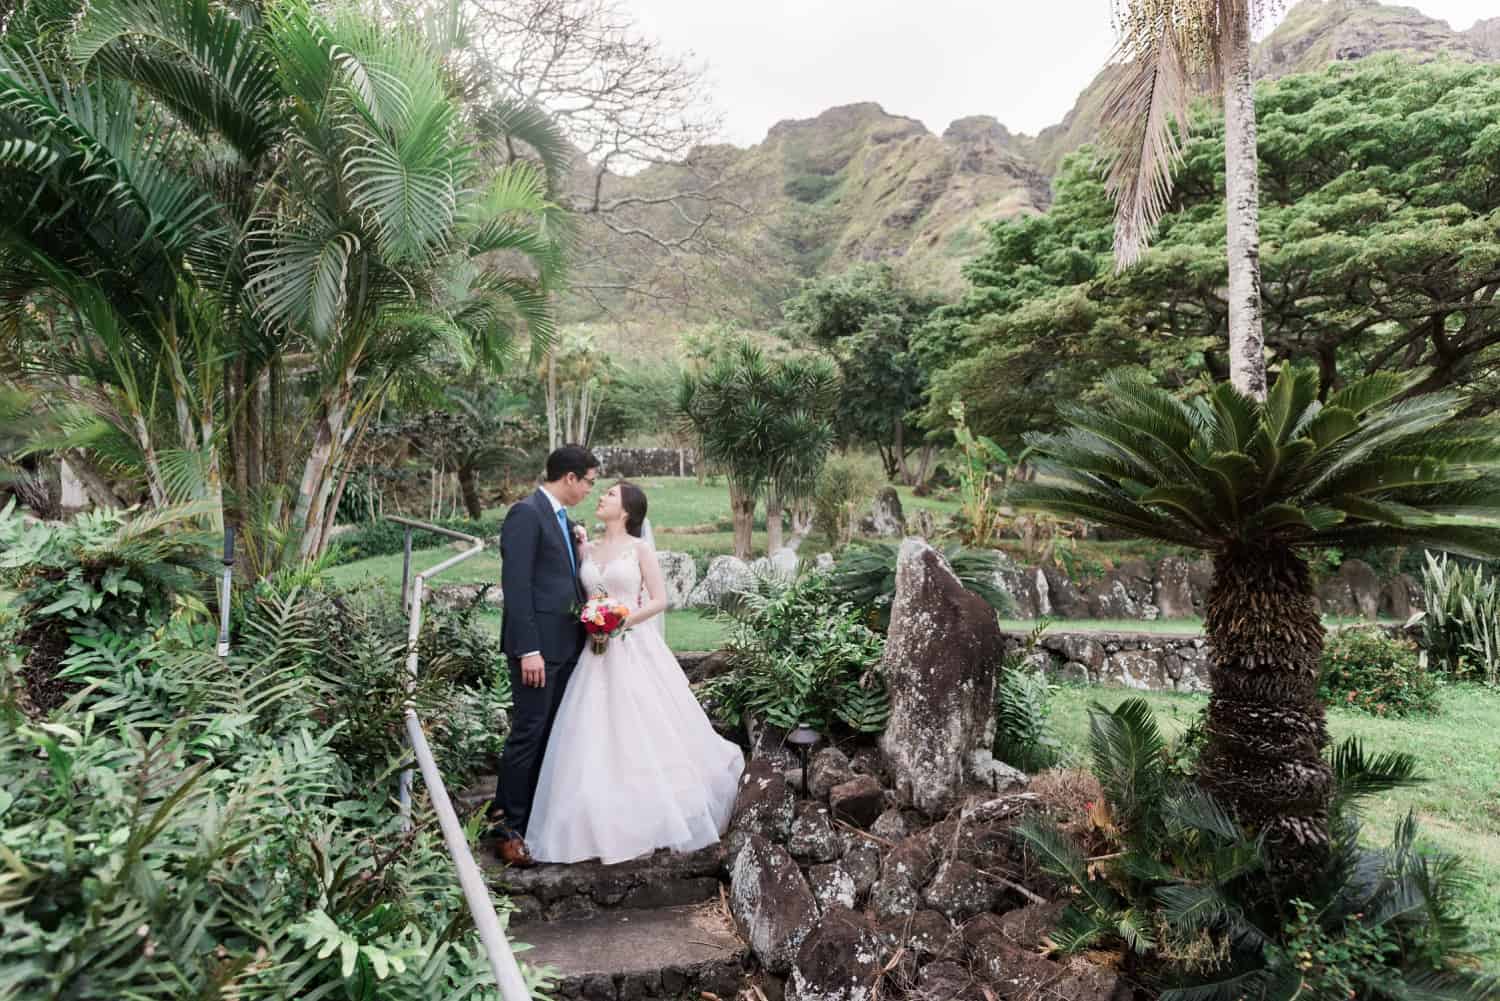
[{"left": 1104, "top": 0, "right": 1278, "bottom": 399}]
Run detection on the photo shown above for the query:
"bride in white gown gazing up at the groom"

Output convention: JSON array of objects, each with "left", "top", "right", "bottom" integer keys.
[{"left": 527, "top": 482, "right": 744, "bottom": 863}]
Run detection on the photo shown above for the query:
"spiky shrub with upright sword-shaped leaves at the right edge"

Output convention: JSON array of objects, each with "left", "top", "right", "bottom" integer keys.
[{"left": 1421, "top": 552, "right": 1500, "bottom": 684}]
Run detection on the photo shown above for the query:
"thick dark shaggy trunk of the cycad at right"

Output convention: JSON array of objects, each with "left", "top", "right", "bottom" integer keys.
[{"left": 1199, "top": 545, "right": 1332, "bottom": 879}]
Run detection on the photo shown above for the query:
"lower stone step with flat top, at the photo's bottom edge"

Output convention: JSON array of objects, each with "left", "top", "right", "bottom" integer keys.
[{"left": 507, "top": 902, "right": 747, "bottom": 1001}]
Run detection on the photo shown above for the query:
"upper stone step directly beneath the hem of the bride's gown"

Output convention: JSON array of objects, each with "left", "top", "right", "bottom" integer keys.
[{"left": 479, "top": 845, "right": 725, "bottom": 921}]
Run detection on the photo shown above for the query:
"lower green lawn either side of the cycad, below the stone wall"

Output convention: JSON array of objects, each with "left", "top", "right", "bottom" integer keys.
[{"left": 1053, "top": 684, "right": 1500, "bottom": 965}]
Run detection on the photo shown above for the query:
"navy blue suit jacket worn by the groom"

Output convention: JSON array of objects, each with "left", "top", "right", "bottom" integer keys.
[{"left": 500, "top": 489, "right": 584, "bottom": 662}]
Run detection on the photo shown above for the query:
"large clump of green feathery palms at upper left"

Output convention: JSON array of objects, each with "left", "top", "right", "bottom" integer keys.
[{"left": 0, "top": 0, "right": 567, "bottom": 563}]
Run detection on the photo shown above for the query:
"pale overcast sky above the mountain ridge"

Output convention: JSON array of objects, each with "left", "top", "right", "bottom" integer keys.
[{"left": 624, "top": 0, "right": 1500, "bottom": 146}]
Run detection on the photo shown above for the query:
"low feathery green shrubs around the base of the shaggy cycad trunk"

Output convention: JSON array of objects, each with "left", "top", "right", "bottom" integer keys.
[{"left": 1017, "top": 699, "right": 1496, "bottom": 1001}]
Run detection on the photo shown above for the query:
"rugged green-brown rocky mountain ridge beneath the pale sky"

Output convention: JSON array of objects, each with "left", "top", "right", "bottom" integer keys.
[{"left": 579, "top": 0, "right": 1500, "bottom": 330}]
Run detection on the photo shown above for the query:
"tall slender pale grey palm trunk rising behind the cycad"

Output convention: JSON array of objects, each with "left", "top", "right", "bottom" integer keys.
[{"left": 1223, "top": 0, "right": 1266, "bottom": 399}]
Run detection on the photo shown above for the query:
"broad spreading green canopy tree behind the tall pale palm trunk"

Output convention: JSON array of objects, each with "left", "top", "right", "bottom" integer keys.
[{"left": 917, "top": 57, "right": 1500, "bottom": 441}]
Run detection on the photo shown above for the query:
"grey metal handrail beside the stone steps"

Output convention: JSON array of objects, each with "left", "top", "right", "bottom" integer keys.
[{"left": 386, "top": 515, "right": 531, "bottom": 1001}]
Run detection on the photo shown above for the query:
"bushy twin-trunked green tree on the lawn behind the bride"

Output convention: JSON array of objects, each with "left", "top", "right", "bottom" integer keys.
[{"left": 678, "top": 341, "right": 839, "bottom": 560}]
